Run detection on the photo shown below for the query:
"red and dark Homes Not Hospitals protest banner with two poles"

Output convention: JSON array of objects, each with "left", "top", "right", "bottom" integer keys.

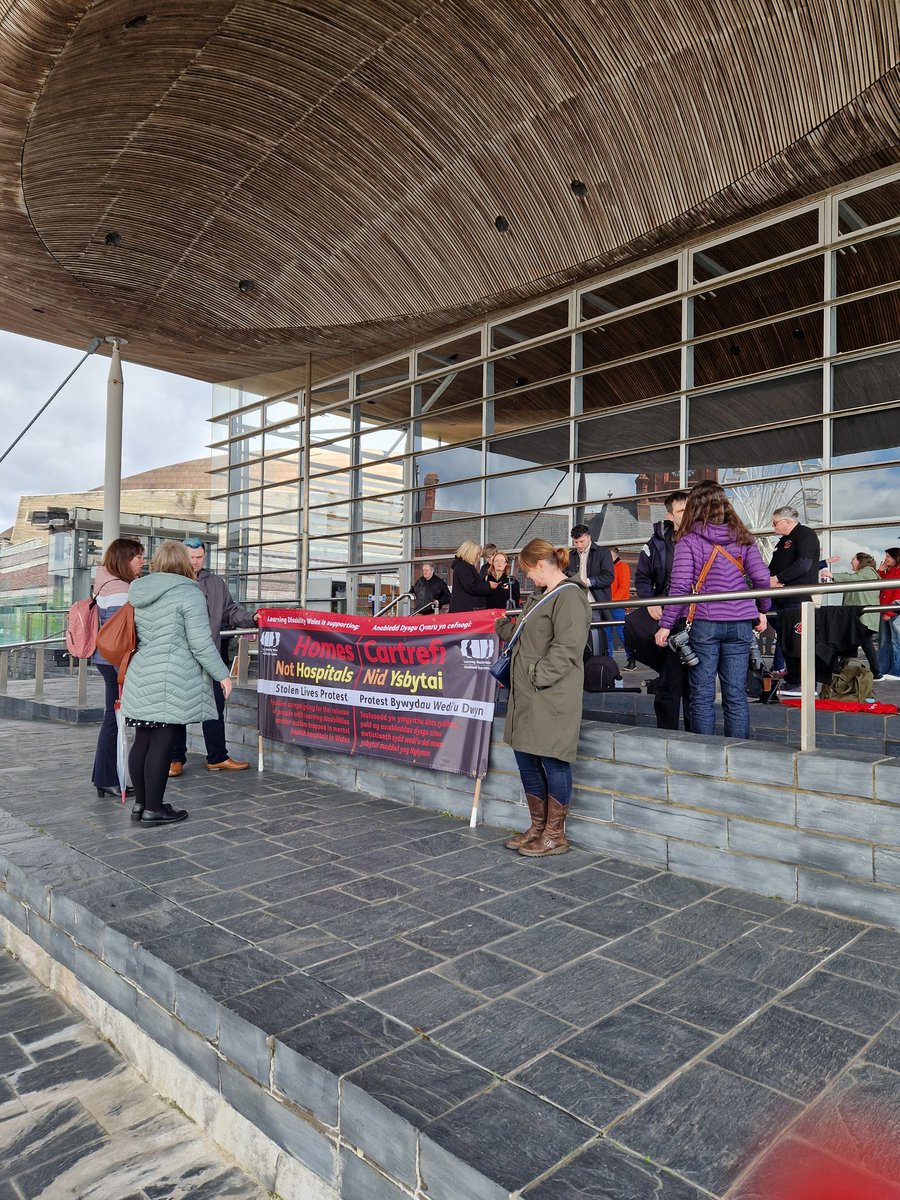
[{"left": 258, "top": 608, "right": 498, "bottom": 776}]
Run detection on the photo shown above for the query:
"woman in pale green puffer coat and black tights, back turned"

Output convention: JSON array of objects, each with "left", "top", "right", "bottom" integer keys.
[{"left": 122, "top": 541, "right": 232, "bottom": 826}]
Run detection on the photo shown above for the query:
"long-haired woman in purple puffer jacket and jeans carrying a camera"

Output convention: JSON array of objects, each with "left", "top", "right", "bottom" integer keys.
[{"left": 656, "top": 479, "right": 772, "bottom": 738}]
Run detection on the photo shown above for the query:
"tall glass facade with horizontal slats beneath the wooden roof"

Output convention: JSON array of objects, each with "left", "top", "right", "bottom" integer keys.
[{"left": 212, "top": 173, "right": 900, "bottom": 612}]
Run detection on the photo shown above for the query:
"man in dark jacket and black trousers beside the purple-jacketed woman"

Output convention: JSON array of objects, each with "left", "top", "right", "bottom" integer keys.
[{"left": 626, "top": 492, "right": 691, "bottom": 731}]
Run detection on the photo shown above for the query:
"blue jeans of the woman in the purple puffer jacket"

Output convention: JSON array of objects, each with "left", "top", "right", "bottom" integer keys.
[{"left": 690, "top": 620, "right": 754, "bottom": 738}]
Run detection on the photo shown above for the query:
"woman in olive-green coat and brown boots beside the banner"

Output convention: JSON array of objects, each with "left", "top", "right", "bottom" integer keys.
[{"left": 494, "top": 538, "right": 590, "bottom": 858}]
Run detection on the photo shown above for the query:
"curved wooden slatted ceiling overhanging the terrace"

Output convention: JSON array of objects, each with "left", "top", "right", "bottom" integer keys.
[{"left": 0, "top": 0, "right": 900, "bottom": 380}]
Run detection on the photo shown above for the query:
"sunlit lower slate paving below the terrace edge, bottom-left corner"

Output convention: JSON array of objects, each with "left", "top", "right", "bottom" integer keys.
[{"left": 0, "top": 950, "right": 266, "bottom": 1200}]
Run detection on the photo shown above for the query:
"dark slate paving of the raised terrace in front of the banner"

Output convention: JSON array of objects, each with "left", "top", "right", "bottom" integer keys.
[{"left": 0, "top": 721, "right": 900, "bottom": 1200}]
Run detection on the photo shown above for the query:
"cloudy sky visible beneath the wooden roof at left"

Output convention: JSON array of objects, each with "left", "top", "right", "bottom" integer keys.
[{"left": 0, "top": 332, "right": 214, "bottom": 529}]
